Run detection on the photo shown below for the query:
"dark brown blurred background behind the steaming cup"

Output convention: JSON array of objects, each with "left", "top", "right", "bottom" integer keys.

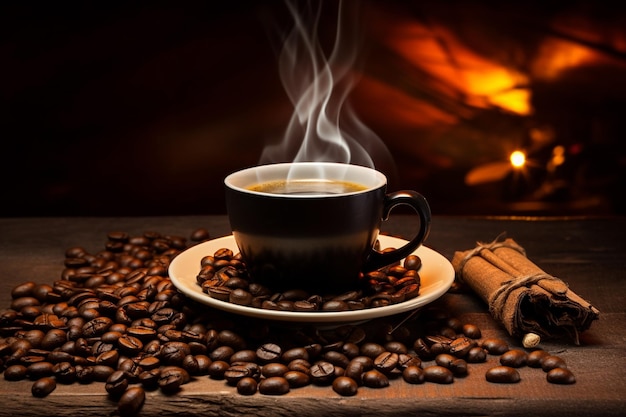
[{"left": 0, "top": 1, "right": 626, "bottom": 216}]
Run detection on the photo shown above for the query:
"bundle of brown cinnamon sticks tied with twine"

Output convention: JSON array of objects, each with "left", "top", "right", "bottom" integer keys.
[{"left": 452, "top": 238, "right": 600, "bottom": 344}]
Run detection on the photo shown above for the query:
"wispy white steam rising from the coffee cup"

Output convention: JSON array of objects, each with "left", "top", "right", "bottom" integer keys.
[{"left": 259, "top": 1, "right": 393, "bottom": 177}]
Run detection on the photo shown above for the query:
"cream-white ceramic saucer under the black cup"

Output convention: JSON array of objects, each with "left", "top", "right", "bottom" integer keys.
[{"left": 169, "top": 235, "right": 454, "bottom": 324}]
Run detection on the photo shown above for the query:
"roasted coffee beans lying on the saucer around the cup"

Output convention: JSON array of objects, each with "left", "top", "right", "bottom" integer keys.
[{"left": 196, "top": 248, "right": 422, "bottom": 312}]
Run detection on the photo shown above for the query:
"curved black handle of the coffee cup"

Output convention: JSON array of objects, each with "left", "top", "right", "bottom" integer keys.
[{"left": 365, "top": 190, "right": 431, "bottom": 271}]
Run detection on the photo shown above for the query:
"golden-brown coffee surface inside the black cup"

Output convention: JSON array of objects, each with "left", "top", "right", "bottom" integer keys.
[{"left": 246, "top": 179, "right": 368, "bottom": 195}]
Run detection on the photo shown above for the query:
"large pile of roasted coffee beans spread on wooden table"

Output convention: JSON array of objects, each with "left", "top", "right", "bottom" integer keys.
[{"left": 0, "top": 229, "right": 575, "bottom": 416}]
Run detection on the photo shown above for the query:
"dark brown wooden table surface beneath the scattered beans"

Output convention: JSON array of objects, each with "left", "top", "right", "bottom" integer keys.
[{"left": 0, "top": 216, "right": 626, "bottom": 416}]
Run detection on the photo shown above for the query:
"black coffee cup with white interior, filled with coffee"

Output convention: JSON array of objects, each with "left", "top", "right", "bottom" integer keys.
[{"left": 224, "top": 162, "right": 431, "bottom": 293}]
